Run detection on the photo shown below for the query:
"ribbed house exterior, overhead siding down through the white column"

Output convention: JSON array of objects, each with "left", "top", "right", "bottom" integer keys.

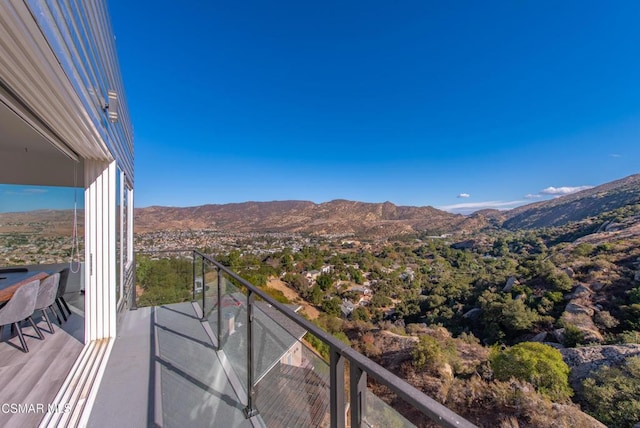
[{"left": 0, "top": 0, "right": 135, "bottom": 342}]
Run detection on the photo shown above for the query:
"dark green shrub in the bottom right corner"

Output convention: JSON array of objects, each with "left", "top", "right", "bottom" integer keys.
[{"left": 582, "top": 356, "right": 640, "bottom": 427}]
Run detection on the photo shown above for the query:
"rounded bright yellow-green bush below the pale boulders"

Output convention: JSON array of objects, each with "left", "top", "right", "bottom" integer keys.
[{"left": 489, "top": 342, "right": 573, "bottom": 402}]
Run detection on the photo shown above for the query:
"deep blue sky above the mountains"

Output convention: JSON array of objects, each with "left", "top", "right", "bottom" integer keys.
[{"left": 2, "top": 0, "right": 640, "bottom": 212}]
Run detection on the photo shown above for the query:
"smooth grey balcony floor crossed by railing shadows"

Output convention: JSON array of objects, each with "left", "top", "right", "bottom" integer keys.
[{"left": 88, "top": 303, "right": 261, "bottom": 427}]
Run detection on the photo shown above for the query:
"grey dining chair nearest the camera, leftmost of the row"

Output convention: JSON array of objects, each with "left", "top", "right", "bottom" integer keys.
[{"left": 0, "top": 279, "right": 44, "bottom": 353}]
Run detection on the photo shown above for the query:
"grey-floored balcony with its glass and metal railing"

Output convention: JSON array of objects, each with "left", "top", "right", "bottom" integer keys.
[{"left": 88, "top": 251, "right": 473, "bottom": 427}]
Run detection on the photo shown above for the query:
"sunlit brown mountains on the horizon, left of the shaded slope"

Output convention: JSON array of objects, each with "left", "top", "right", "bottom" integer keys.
[{"left": 135, "top": 200, "right": 484, "bottom": 237}]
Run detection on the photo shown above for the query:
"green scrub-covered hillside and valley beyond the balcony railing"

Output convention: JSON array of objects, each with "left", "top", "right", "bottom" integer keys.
[{"left": 138, "top": 201, "right": 640, "bottom": 426}]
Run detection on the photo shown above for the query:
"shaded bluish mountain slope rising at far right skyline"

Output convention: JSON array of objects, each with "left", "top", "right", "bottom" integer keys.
[{"left": 502, "top": 174, "right": 640, "bottom": 230}]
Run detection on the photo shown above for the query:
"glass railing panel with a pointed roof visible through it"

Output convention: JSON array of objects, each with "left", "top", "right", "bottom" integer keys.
[{"left": 253, "top": 301, "right": 330, "bottom": 427}]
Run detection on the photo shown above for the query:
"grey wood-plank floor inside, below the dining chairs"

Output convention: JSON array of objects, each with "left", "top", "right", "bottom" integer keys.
[{"left": 0, "top": 314, "right": 84, "bottom": 428}]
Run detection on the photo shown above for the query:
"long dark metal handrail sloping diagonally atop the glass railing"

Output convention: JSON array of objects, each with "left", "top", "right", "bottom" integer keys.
[{"left": 193, "top": 250, "right": 475, "bottom": 427}]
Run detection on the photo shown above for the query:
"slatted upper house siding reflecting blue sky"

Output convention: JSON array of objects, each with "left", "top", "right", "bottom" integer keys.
[{"left": 26, "top": 0, "right": 134, "bottom": 179}]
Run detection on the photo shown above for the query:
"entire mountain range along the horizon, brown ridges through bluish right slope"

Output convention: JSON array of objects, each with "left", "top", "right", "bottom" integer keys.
[{"left": 135, "top": 174, "right": 640, "bottom": 238}]
